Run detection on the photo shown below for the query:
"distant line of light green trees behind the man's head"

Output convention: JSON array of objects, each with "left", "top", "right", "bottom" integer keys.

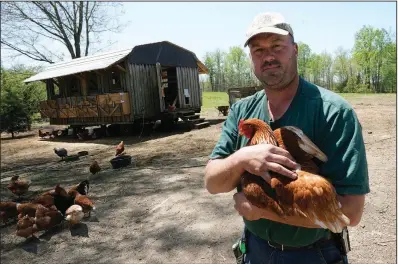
[{"left": 201, "top": 26, "right": 397, "bottom": 93}]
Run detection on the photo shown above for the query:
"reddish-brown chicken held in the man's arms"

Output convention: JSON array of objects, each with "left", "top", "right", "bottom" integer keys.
[{"left": 238, "top": 118, "right": 350, "bottom": 233}]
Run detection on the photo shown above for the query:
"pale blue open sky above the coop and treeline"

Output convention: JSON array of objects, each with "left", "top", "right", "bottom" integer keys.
[{"left": 1, "top": 2, "right": 397, "bottom": 67}]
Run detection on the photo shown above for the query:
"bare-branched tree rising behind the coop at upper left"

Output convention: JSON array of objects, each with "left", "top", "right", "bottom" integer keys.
[{"left": 1, "top": 1, "right": 122, "bottom": 63}]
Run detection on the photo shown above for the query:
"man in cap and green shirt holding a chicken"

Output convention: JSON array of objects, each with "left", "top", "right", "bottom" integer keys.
[{"left": 204, "top": 13, "right": 370, "bottom": 264}]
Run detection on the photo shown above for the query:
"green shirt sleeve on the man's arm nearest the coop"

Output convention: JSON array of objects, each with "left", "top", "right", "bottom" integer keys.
[{"left": 209, "top": 104, "right": 238, "bottom": 159}]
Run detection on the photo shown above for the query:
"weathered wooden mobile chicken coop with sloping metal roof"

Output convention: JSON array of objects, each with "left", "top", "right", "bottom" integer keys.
[{"left": 24, "top": 41, "right": 208, "bottom": 132}]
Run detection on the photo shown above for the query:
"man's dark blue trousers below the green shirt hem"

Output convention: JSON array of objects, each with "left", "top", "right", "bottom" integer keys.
[{"left": 244, "top": 231, "right": 348, "bottom": 264}]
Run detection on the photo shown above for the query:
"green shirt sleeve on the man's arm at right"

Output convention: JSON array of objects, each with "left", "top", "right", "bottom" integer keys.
[{"left": 320, "top": 108, "right": 370, "bottom": 195}]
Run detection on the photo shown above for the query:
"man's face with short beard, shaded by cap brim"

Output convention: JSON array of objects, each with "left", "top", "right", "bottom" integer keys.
[{"left": 249, "top": 33, "right": 297, "bottom": 90}]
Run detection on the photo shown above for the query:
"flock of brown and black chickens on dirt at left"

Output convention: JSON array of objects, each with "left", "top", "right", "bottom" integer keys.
[{"left": 0, "top": 141, "right": 124, "bottom": 238}]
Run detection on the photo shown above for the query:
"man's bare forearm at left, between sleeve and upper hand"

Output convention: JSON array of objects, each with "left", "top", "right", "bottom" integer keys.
[{"left": 204, "top": 154, "right": 243, "bottom": 194}]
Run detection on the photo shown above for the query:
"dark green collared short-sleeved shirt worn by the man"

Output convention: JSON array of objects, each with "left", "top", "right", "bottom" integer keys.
[{"left": 210, "top": 78, "right": 370, "bottom": 246}]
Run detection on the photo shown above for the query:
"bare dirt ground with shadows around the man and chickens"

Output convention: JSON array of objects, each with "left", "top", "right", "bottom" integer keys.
[{"left": 0, "top": 96, "right": 396, "bottom": 264}]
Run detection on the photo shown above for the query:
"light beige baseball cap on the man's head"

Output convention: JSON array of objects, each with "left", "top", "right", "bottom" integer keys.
[{"left": 244, "top": 12, "right": 293, "bottom": 47}]
